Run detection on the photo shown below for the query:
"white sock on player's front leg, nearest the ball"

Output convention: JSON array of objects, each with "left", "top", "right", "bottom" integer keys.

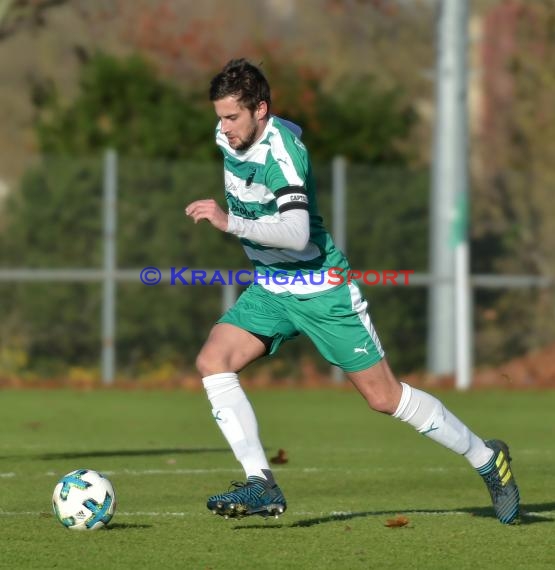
[{"left": 202, "top": 372, "right": 273, "bottom": 481}]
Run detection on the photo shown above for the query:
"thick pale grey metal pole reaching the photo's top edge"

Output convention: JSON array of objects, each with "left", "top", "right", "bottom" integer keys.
[{"left": 428, "top": 0, "right": 468, "bottom": 382}]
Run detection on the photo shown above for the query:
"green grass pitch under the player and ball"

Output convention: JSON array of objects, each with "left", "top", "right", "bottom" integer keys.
[{"left": 0, "top": 390, "right": 555, "bottom": 570}]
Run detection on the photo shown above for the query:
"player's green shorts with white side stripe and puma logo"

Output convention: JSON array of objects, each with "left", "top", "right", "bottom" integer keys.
[{"left": 218, "top": 283, "right": 384, "bottom": 372}]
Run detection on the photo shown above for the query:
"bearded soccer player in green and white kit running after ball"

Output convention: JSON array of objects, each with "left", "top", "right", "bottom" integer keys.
[{"left": 185, "top": 59, "right": 519, "bottom": 524}]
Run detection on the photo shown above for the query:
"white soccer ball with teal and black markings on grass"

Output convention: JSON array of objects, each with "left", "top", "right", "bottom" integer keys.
[{"left": 52, "top": 469, "right": 116, "bottom": 530}]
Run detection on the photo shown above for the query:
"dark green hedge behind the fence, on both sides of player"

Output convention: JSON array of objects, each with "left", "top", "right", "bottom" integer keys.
[{"left": 0, "top": 50, "right": 427, "bottom": 376}]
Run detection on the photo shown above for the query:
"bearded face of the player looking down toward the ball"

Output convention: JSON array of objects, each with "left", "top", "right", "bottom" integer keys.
[{"left": 214, "top": 95, "right": 267, "bottom": 150}]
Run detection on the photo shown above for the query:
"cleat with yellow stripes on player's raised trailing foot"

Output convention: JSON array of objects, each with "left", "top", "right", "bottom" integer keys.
[{"left": 478, "top": 439, "right": 520, "bottom": 524}]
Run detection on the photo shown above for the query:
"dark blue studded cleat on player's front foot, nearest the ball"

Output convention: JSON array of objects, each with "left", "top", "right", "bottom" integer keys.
[{"left": 206, "top": 476, "right": 287, "bottom": 519}]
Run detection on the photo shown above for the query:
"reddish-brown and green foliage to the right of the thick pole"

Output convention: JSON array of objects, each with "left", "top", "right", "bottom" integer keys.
[{"left": 473, "top": 0, "right": 555, "bottom": 361}]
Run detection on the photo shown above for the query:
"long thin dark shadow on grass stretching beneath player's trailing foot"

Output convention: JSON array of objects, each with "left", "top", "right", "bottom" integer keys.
[{"left": 233, "top": 502, "right": 555, "bottom": 530}]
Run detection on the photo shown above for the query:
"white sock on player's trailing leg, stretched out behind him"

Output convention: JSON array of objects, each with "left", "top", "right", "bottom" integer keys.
[{"left": 393, "top": 382, "right": 493, "bottom": 469}]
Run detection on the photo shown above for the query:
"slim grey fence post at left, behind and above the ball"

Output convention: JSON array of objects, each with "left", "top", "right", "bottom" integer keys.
[{"left": 102, "top": 150, "right": 118, "bottom": 384}]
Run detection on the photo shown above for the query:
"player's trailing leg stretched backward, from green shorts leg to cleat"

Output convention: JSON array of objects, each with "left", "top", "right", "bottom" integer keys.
[{"left": 290, "top": 283, "right": 519, "bottom": 523}]
